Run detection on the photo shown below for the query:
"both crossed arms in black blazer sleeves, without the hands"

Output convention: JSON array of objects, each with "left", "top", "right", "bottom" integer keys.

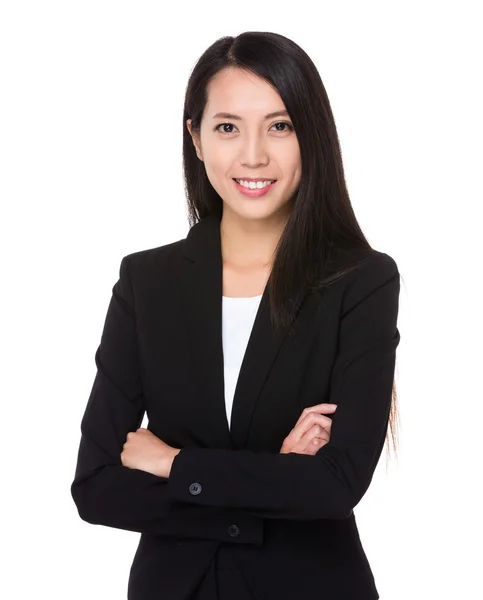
[{"left": 71, "top": 254, "right": 400, "bottom": 543}]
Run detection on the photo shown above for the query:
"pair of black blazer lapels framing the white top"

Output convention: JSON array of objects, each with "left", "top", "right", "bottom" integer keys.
[{"left": 179, "top": 215, "right": 304, "bottom": 450}]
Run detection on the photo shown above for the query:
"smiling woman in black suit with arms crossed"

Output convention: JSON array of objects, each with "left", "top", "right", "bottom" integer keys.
[{"left": 71, "top": 32, "right": 400, "bottom": 600}]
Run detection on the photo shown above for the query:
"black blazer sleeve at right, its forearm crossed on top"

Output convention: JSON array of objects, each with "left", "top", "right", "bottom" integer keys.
[{"left": 169, "top": 253, "right": 400, "bottom": 520}]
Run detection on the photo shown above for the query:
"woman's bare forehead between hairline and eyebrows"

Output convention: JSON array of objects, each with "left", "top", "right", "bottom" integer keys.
[{"left": 205, "top": 67, "right": 285, "bottom": 119}]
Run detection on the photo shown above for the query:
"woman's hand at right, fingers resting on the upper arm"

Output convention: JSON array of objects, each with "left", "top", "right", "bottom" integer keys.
[{"left": 280, "top": 403, "right": 337, "bottom": 456}]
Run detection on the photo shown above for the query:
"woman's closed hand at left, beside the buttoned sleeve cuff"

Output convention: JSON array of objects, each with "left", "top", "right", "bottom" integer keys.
[{"left": 121, "top": 427, "right": 181, "bottom": 478}]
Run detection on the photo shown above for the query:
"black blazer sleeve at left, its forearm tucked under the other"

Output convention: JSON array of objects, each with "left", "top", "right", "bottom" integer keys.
[{"left": 71, "top": 257, "right": 263, "bottom": 544}]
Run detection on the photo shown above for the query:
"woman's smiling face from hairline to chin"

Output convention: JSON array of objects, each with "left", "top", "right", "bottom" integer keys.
[{"left": 186, "top": 67, "right": 301, "bottom": 227}]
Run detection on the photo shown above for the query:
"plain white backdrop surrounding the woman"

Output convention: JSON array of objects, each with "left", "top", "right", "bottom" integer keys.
[{"left": 0, "top": 0, "right": 483, "bottom": 600}]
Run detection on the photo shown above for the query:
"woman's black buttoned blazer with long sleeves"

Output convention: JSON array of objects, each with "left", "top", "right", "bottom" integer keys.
[{"left": 71, "top": 216, "right": 400, "bottom": 600}]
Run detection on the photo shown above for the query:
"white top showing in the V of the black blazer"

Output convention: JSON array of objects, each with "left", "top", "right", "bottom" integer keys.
[{"left": 222, "top": 294, "right": 263, "bottom": 429}]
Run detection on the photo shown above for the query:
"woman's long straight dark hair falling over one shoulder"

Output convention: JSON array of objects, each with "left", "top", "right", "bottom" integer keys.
[{"left": 183, "top": 31, "right": 397, "bottom": 460}]
